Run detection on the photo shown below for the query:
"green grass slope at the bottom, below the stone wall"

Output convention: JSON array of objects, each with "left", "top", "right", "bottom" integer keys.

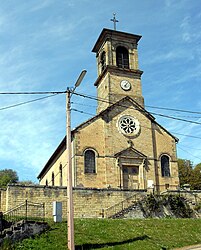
[{"left": 9, "top": 219, "right": 201, "bottom": 250}]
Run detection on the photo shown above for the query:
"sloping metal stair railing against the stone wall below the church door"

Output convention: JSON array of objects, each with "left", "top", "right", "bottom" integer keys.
[{"left": 102, "top": 193, "right": 143, "bottom": 218}]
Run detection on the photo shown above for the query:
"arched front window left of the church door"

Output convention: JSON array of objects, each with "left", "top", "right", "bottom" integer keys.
[{"left": 84, "top": 149, "right": 96, "bottom": 174}]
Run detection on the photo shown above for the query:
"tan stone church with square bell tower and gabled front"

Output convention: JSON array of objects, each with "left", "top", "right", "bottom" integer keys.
[{"left": 38, "top": 29, "right": 179, "bottom": 193}]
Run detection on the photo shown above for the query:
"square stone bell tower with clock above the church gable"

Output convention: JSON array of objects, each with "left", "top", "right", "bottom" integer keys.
[{"left": 92, "top": 29, "right": 144, "bottom": 113}]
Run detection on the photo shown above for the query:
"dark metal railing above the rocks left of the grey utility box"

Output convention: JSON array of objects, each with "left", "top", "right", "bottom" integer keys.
[{"left": 3, "top": 200, "right": 45, "bottom": 222}]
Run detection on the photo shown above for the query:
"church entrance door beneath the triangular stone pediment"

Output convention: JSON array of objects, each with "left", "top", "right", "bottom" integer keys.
[{"left": 123, "top": 166, "right": 139, "bottom": 189}]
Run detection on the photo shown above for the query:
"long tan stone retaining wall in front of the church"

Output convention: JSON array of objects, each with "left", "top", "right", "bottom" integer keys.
[{"left": 1, "top": 184, "right": 145, "bottom": 218}]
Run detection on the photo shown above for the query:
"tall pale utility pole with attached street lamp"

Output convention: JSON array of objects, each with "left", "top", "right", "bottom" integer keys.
[{"left": 66, "top": 70, "right": 87, "bottom": 250}]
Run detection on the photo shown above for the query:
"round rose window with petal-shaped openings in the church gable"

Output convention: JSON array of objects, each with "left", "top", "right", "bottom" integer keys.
[{"left": 119, "top": 115, "right": 140, "bottom": 135}]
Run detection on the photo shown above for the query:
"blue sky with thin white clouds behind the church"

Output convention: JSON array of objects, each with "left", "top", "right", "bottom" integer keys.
[{"left": 0, "top": 0, "right": 201, "bottom": 182}]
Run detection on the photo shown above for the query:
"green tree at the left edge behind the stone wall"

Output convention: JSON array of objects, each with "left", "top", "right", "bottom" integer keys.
[{"left": 0, "top": 169, "right": 19, "bottom": 188}]
